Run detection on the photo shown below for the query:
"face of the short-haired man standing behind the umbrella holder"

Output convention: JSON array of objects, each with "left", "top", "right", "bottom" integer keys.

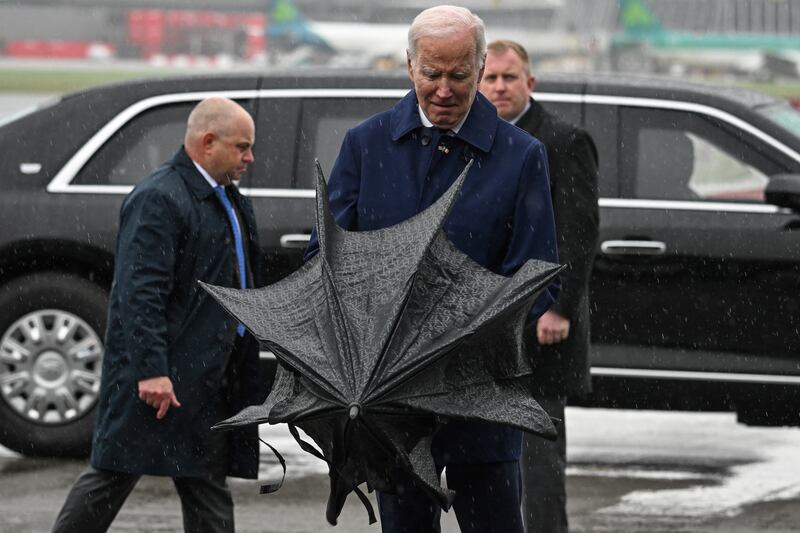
[{"left": 480, "top": 50, "right": 535, "bottom": 120}]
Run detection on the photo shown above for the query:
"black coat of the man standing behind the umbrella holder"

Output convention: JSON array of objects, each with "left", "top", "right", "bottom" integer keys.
[{"left": 517, "top": 99, "right": 599, "bottom": 396}]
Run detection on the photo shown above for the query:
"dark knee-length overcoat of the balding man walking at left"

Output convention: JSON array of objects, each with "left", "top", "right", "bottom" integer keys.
[{"left": 91, "top": 148, "right": 264, "bottom": 478}]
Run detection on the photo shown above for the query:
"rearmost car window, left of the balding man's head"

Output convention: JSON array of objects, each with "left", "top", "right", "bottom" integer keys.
[{"left": 73, "top": 102, "right": 195, "bottom": 185}]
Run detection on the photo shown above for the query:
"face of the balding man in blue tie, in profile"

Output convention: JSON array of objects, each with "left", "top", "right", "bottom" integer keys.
[{"left": 206, "top": 113, "right": 255, "bottom": 185}]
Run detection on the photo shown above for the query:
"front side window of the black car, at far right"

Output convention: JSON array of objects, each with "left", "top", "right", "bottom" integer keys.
[{"left": 622, "top": 109, "right": 779, "bottom": 202}]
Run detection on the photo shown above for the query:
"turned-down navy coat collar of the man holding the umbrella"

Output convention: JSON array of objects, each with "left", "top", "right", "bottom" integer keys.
[{"left": 389, "top": 90, "right": 500, "bottom": 152}]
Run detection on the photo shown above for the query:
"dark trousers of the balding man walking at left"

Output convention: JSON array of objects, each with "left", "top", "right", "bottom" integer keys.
[{"left": 53, "top": 466, "right": 234, "bottom": 533}]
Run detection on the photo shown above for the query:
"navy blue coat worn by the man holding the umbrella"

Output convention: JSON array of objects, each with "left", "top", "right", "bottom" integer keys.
[{"left": 306, "top": 91, "right": 558, "bottom": 464}]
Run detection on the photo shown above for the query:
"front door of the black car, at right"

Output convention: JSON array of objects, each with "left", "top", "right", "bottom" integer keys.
[{"left": 591, "top": 102, "right": 800, "bottom": 379}]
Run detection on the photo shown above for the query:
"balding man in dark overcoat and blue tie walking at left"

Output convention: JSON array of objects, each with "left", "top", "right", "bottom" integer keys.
[{"left": 54, "top": 97, "right": 263, "bottom": 532}]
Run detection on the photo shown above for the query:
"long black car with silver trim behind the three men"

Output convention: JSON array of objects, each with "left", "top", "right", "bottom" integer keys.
[{"left": 0, "top": 72, "right": 800, "bottom": 455}]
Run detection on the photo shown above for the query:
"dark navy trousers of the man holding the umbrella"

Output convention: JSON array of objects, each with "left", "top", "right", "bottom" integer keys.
[{"left": 378, "top": 461, "right": 523, "bottom": 533}]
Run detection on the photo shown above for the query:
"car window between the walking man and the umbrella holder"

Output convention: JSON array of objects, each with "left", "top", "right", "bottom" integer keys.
[{"left": 296, "top": 98, "right": 397, "bottom": 189}]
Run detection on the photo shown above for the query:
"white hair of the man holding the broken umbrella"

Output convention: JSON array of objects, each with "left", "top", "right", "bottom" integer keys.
[{"left": 408, "top": 5, "right": 486, "bottom": 67}]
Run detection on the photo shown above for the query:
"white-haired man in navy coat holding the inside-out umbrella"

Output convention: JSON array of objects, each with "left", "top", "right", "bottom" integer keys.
[{"left": 307, "top": 6, "right": 557, "bottom": 533}]
